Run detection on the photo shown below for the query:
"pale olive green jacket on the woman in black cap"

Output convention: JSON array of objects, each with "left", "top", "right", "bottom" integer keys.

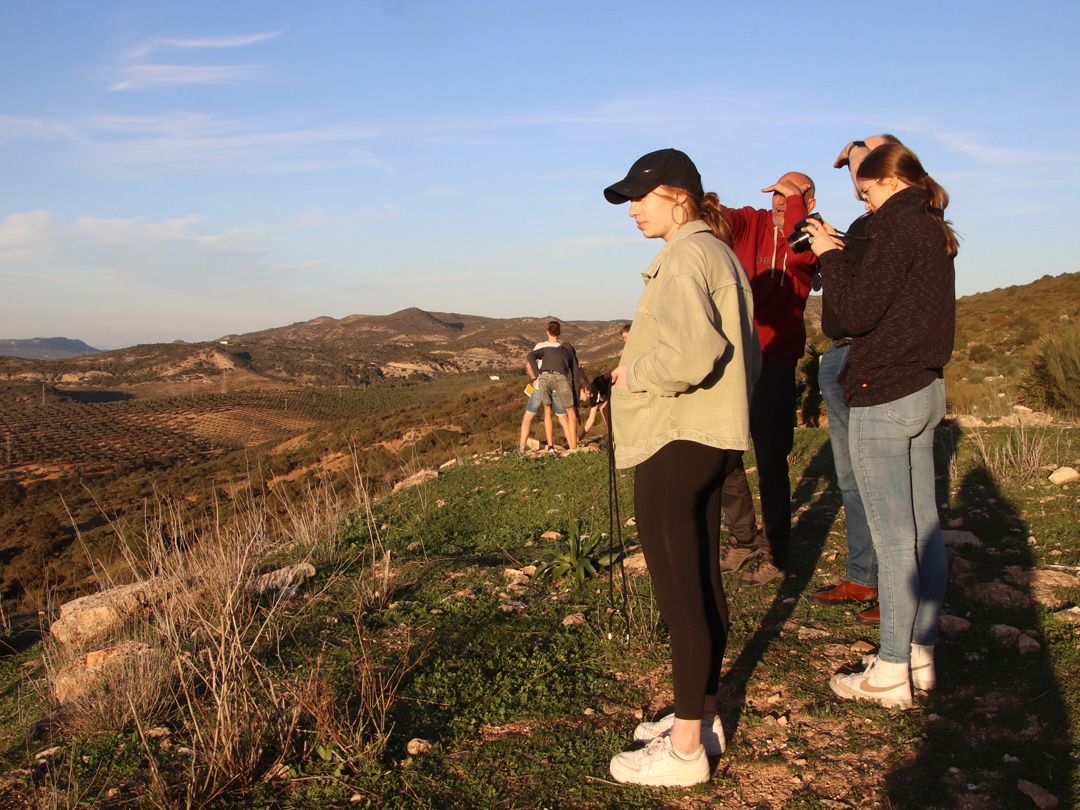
[{"left": 611, "top": 220, "right": 761, "bottom": 468}]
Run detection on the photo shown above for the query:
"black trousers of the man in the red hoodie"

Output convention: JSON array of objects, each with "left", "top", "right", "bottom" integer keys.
[{"left": 750, "top": 363, "right": 795, "bottom": 568}]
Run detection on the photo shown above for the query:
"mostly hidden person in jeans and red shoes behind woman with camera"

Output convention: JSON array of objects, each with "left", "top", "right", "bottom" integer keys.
[{"left": 810, "top": 135, "right": 900, "bottom": 624}]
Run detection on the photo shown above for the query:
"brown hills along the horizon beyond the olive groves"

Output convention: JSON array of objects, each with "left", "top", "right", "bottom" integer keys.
[{"left": 0, "top": 308, "right": 625, "bottom": 390}]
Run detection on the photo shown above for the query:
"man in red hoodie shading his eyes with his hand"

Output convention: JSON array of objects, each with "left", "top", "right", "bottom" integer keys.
[{"left": 721, "top": 172, "right": 818, "bottom": 588}]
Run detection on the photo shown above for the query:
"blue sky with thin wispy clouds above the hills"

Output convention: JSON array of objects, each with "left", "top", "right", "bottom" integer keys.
[{"left": 0, "top": 0, "right": 1080, "bottom": 348}]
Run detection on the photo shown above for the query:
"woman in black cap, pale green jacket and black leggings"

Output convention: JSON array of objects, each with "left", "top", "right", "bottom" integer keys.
[{"left": 604, "top": 149, "right": 761, "bottom": 785}]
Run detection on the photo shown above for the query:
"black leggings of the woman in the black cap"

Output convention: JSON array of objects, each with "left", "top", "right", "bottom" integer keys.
[{"left": 634, "top": 441, "right": 742, "bottom": 720}]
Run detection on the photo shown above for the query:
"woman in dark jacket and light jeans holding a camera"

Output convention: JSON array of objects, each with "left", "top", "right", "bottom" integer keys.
[{"left": 806, "top": 144, "right": 957, "bottom": 708}]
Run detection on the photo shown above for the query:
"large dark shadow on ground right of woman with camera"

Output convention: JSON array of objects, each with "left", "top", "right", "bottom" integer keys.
[{"left": 886, "top": 467, "right": 1076, "bottom": 810}]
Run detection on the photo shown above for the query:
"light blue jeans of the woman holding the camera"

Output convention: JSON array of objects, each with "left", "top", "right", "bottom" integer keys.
[{"left": 848, "top": 379, "right": 948, "bottom": 663}]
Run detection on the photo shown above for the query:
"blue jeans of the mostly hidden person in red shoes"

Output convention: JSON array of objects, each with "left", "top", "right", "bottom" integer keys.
[{"left": 818, "top": 346, "right": 877, "bottom": 588}]
